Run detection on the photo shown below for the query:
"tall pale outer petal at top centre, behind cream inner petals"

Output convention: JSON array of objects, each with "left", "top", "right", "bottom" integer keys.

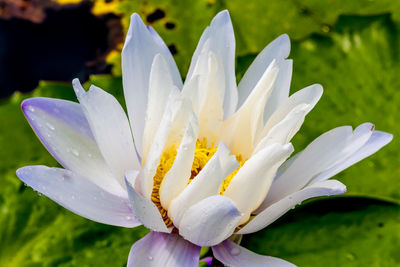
[{"left": 187, "top": 10, "right": 238, "bottom": 118}]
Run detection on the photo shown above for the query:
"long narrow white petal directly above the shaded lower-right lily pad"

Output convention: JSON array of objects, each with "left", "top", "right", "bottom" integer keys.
[{"left": 237, "top": 180, "right": 346, "bottom": 234}]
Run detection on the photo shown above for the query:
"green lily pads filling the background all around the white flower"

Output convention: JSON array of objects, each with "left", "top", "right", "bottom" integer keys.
[{"left": 0, "top": 0, "right": 400, "bottom": 267}]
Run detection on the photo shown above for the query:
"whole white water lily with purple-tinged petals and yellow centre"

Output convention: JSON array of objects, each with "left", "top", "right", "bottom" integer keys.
[{"left": 17, "top": 11, "right": 392, "bottom": 266}]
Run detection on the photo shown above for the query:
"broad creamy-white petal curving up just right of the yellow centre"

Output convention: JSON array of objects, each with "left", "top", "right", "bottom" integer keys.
[{"left": 224, "top": 144, "right": 293, "bottom": 224}]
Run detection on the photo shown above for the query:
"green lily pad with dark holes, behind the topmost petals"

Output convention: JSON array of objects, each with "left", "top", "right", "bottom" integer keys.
[{"left": 104, "top": 0, "right": 400, "bottom": 76}]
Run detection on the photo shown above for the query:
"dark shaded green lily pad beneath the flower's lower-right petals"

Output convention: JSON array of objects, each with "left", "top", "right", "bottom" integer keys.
[{"left": 242, "top": 197, "right": 400, "bottom": 267}]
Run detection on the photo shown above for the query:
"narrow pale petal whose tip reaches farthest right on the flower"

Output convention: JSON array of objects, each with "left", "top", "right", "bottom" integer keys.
[{"left": 310, "top": 131, "right": 393, "bottom": 184}]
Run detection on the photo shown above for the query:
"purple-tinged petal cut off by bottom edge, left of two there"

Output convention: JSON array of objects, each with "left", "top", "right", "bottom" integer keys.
[{"left": 127, "top": 232, "right": 200, "bottom": 267}]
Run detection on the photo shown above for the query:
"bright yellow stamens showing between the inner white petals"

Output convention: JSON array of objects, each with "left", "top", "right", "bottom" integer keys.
[{"left": 151, "top": 138, "right": 245, "bottom": 227}]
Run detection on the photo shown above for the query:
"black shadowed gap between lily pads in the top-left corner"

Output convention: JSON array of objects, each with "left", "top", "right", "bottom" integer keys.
[{"left": 0, "top": 4, "right": 110, "bottom": 98}]
